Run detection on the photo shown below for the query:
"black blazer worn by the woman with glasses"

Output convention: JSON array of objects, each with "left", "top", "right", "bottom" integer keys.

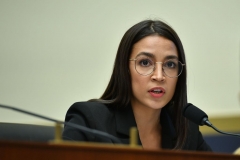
[{"left": 63, "top": 102, "right": 211, "bottom": 151}]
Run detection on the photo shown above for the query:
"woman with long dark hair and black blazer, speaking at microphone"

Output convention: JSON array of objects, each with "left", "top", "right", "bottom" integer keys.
[{"left": 63, "top": 20, "right": 211, "bottom": 151}]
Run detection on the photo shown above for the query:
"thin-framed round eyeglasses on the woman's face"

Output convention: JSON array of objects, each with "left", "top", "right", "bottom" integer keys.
[{"left": 129, "top": 56, "right": 185, "bottom": 78}]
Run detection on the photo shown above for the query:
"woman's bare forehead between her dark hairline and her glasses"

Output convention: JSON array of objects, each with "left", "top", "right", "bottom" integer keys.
[{"left": 130, "top": 35, "right": 178, "bottom": 59}]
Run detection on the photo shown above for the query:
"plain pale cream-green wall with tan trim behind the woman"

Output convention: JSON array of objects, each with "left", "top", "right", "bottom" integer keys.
[{"left": 0, "top": 0, "right": 240, "bottom": 154}]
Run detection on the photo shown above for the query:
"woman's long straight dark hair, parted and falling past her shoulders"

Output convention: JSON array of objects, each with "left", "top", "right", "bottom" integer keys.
[{"left": 90, "top": 20, "right": 188, "bottom": 149}]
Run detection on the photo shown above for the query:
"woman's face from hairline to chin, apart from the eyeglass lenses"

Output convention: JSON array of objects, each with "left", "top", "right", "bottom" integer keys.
[{"left": 129, "top": 35, "right": 178, "bottom": 109}]
